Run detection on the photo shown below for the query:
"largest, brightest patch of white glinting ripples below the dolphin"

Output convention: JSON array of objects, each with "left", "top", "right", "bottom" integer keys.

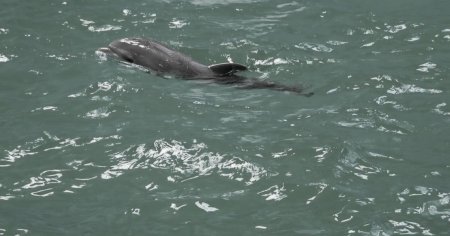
[{"left": 102, "top": 140, "right": 269, "bottom": 185}]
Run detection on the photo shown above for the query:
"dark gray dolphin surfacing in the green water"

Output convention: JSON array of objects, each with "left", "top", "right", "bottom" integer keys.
[{"left": 98, "top": 38, "right": 313, "bottom": 96}]
